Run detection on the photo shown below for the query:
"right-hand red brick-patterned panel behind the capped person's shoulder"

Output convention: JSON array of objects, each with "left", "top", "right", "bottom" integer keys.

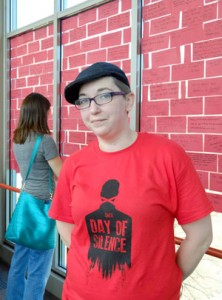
[{"left": 140, "top": 0, "right": 222, "bottom": 212}]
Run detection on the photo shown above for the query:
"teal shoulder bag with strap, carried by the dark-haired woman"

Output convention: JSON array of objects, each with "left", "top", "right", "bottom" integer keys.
[{"left": 5, "top": 135, "right": 56, "bottom": 250}]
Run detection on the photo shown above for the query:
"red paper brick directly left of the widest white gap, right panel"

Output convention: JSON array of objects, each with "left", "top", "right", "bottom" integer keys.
[{"left": 152, "top": 48, "right": 180, "bottom": 68}]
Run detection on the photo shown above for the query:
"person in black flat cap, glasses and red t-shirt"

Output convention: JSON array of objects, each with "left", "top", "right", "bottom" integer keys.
[{"left": 50, "top": 62, "right": 212, "bottom": 300}]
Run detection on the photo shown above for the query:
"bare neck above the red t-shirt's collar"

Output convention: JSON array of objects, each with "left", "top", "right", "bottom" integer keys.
[{"left": 98, "top": 129, "right": 137, "bottom": 152}]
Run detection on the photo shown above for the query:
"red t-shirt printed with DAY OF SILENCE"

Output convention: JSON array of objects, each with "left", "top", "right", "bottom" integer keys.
[{"left": 50, "top": 133, "right": 212, "bottom": 300}]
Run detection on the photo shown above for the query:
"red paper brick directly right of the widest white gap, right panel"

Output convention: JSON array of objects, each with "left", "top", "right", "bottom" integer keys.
[{"left": 193, "top": 38, "right": 222, "bottom": 60}]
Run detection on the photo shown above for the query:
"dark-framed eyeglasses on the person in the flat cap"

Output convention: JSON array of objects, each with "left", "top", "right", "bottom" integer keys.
[{"left": 74, "top": 92, "right": 126, "bottom": 110}]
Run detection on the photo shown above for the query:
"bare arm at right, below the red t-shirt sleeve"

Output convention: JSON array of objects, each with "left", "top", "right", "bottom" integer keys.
[{"left": 177, "top": 215, "right": 213, "bottom": 280}]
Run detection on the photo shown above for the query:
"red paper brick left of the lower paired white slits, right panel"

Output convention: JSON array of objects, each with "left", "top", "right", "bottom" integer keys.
[{"left": 150, "top": 83, "right": 179, "bottom": 100}]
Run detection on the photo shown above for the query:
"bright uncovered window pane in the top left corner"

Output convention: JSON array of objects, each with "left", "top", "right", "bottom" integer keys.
[{"left": 12, "top": 0, "right": 54, "bottom": 29}]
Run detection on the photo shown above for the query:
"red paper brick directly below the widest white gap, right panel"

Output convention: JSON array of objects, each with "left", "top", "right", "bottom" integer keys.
[{"left": 172, "top": 61, "right": 204, "bottom": 81}]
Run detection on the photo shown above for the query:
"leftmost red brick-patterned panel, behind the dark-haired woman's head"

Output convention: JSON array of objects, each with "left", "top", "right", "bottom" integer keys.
[{"left": 10, "top": 25, "right": 53, "bottom": 169}]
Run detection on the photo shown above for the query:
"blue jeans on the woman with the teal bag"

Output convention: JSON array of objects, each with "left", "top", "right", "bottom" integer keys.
[{"left": 6, "top": 244, "right": 54, "bottom": 300}]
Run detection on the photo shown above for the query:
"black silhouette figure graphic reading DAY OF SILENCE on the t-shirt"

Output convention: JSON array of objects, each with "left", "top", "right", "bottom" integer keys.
[{"left": 85, "top": 179, "right": 132, "bottom": 278}]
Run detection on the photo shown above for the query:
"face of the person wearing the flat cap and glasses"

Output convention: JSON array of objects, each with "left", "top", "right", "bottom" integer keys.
[{"left": 79, "top": 77, "right": 134, "bottom": 138}]
